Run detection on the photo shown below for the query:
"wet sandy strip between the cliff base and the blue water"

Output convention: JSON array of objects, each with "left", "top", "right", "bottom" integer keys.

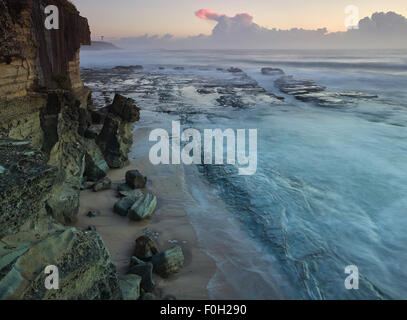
[{"left": 72, "top": 127, "right": 216, "bottom": 300}]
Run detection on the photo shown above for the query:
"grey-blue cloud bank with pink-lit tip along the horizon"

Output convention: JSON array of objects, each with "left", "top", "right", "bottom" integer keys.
[{"left": 113, "top": 9, "right": 407, "bottom": 49}]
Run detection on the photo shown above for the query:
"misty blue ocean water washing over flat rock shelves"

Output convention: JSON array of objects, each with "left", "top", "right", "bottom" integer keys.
[{"left": 81, "top": 50, "right": 407, "bottom": 299}]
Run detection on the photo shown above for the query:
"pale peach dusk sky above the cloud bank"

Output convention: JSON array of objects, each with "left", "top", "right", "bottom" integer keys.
[{"left": 72, "top": 0, "right": 407, "bottom": 39}]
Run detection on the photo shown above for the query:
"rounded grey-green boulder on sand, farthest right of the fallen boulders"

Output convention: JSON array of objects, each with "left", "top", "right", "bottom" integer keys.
[{"left": 151, "top": 246, "right": 184, "bottom": 278}]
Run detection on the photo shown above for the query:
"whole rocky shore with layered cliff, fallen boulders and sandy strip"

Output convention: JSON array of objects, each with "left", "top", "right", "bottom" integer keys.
[{"left": 0, "top": 0, "right": 214, "bottom": 300}]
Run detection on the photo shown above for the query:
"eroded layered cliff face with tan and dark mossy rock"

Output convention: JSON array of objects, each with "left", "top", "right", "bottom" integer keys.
[{"left": 0, "top": 0, "right": 139, "bottom": 299}]
